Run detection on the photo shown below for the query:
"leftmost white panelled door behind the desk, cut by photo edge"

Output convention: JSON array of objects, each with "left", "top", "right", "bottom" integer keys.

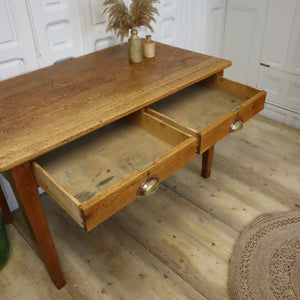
[{"left": 0, "top": 0, "right": 38, "bottom": 80}]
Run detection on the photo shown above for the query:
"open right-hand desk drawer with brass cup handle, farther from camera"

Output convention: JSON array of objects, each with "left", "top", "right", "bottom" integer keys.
[{"left": 147, "top": 75, "right": 266, "bottom": 154}]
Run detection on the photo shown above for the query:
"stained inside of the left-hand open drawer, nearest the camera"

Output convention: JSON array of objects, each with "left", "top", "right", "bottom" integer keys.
[{"left": 35, "top": 112, "right": 189, "bottom": 203}]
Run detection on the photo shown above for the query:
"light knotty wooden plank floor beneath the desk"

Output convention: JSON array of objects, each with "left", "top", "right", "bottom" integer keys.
[{"left": 0, "top": 116, "right": 300, "bottom": 300}]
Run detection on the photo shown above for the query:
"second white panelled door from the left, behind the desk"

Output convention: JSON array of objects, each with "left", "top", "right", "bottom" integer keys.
[{"left": 28, "top": 0, "right": 84, "bottom": 67}]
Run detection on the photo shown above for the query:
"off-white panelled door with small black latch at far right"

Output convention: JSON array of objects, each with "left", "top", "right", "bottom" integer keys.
[{"left": 258, "top": 0, "right": 300, "bottom": 129}]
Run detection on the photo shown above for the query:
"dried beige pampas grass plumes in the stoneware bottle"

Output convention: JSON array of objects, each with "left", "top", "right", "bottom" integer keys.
[{"left": 103, "top": 0, "right": 159, "bottom": 42}]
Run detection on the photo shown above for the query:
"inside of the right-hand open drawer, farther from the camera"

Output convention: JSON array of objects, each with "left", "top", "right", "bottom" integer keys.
[{"left": 149, "top": 75, "right": 260, "bottom": 132}]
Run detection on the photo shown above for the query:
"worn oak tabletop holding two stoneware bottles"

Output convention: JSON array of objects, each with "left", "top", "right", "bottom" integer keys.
[{"left": 0, "top": 43, "right": 231, "bottom": 172}]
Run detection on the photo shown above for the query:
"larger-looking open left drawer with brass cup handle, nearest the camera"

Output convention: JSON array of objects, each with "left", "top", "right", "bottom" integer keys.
[{"left": 33, "top": 112, "right": 197, "bottom": 231}]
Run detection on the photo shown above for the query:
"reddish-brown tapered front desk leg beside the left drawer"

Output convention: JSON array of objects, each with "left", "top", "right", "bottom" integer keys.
[{"left": 11, "top": 162, "right": 66, "bottom": 289}]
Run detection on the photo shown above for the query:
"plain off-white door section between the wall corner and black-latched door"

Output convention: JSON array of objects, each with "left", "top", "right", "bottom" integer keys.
[{"left": 223, "top": 0, "right": 270, "bottom": 86}]
